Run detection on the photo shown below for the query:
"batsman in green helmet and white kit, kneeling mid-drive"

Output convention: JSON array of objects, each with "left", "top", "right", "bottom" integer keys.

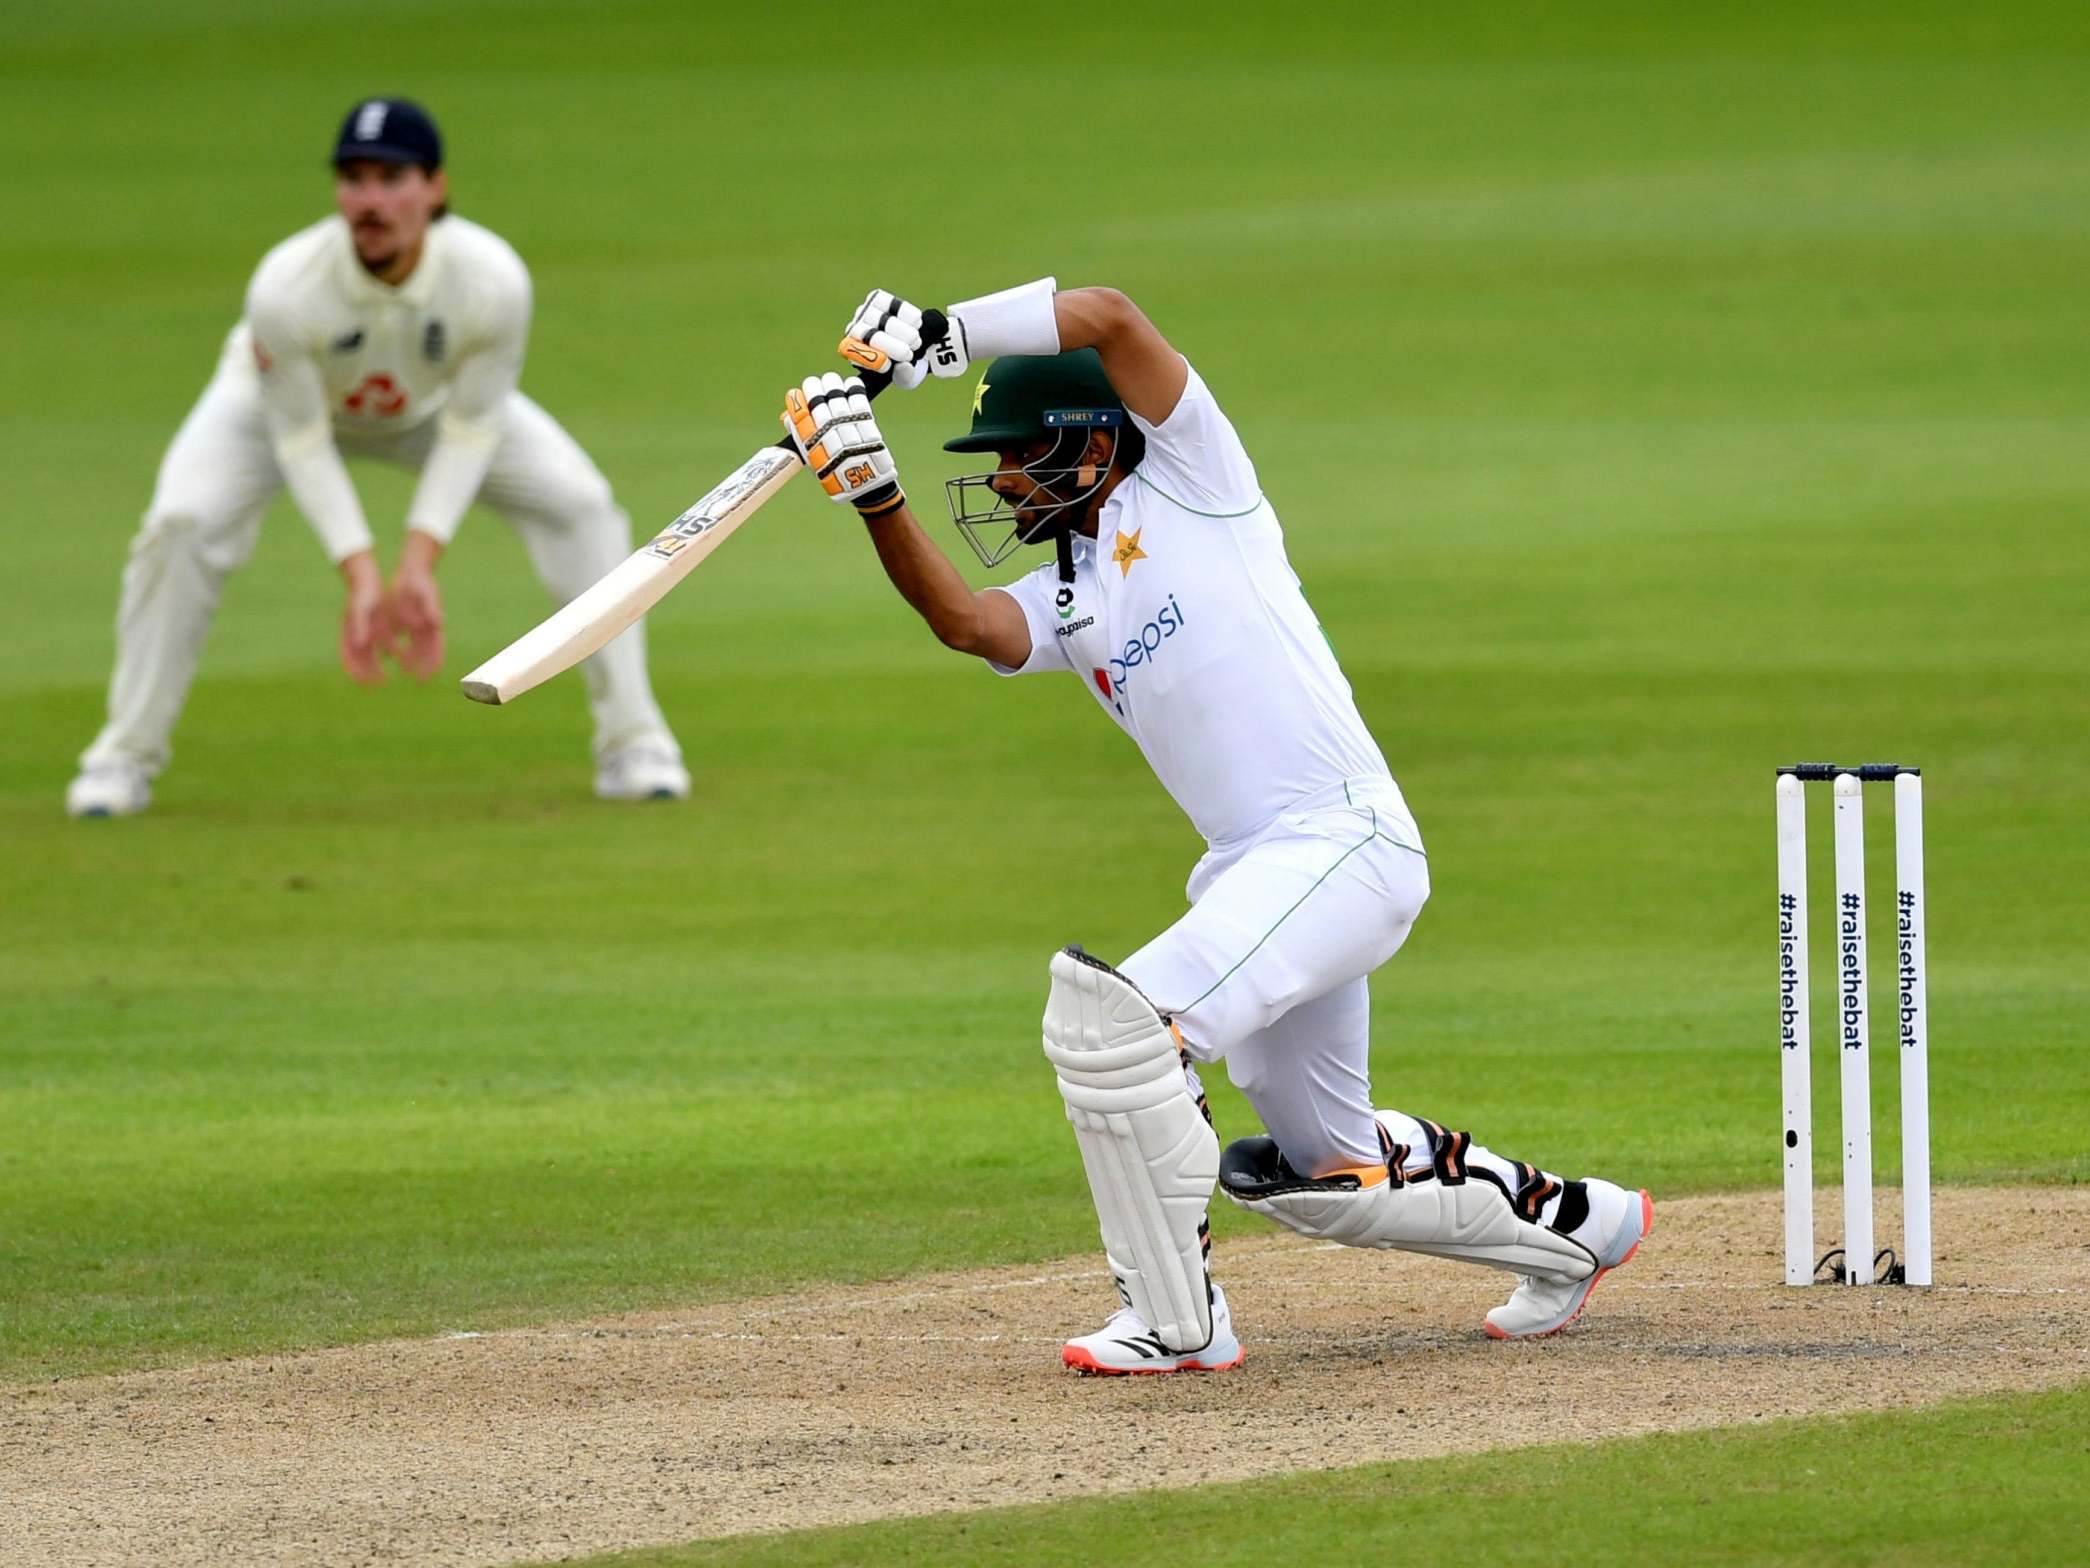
[{"left": 784, "top": 278, "right": 1653, "bottom": 1374}]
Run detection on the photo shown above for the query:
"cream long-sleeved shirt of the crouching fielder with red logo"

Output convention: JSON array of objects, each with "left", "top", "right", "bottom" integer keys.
[{"left": 226, "top": 213, "right": 531, "bottom": 560}]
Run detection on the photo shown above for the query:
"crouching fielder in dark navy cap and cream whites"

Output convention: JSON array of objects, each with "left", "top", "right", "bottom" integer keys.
[{"left": 65, "top": 98, "right": 690, "bottom": 817}]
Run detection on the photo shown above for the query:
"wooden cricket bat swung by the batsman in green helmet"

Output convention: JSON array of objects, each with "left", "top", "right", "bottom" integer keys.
[{"left": 462, "top": 309, "right": 947, "bottom": 707}]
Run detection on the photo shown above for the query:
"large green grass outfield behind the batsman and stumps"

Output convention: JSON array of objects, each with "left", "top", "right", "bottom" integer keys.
[{"left": 0, "top": 2, "right": 2090, "bottom": 1538}]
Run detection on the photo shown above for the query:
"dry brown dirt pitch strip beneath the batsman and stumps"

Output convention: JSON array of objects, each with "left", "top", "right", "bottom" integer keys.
[{"left": 0, "top": 1187, "right": 2090, "bottom": 1568}]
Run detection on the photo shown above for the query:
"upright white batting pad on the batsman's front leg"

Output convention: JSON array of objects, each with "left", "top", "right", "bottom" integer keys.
[{"left": 1045, "top": 947, "right": 1218, "bottom": 1353}]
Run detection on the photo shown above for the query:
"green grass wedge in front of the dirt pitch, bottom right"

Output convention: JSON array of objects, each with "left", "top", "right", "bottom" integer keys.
[{"left": 564, "top": 1388, "right": 2090, "bottom": 1568}]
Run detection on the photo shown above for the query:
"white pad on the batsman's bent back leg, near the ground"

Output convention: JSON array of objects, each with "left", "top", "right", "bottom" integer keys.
[{"left": 1221, "top": 1137, "right": 1597, "bottom": 1284}]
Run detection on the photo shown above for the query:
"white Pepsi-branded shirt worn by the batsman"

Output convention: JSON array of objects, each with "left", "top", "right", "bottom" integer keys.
[{"left": 986, "top": 370, "right": 1419, "bottom": 843}]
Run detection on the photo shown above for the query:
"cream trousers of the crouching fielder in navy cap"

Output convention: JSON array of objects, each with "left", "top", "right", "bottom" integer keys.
[{"left": 79, "top": 353, "right": 667, "bottom": 776}]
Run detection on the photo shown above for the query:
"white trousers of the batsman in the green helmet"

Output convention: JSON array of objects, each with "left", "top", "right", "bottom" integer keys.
[{"left": 1120, "top": 778, "right": 1430, "bottom": 1175}]
